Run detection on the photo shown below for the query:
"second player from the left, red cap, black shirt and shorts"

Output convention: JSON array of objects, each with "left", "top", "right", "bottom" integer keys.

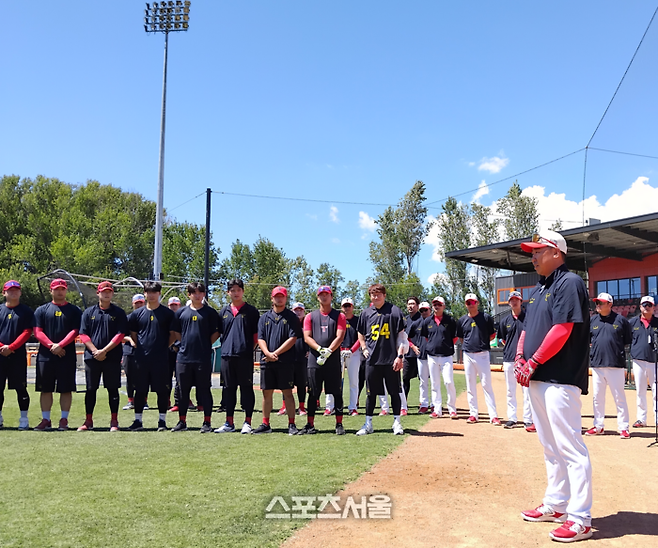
[{"left": 34, "top": 278, "right": 82, "bottom": 431}]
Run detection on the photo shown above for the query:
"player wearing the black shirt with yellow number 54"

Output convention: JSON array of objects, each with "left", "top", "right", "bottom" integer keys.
[{"left": 356, "top": 284, "right": 409, "bottom": 436}]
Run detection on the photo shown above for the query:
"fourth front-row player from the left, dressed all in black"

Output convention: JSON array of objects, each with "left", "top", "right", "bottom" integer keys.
[{"left": 128, "top": 281, "right": 176, "bottom": 432}]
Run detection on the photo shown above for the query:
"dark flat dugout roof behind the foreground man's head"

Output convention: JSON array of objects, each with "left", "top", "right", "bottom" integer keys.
[{"left": 446, "top": 213, "right": 658, "bottom": 272}]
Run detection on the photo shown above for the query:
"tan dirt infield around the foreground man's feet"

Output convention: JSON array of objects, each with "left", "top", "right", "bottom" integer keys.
[{"left": 283, "top": 373, "right": 658, "bottom": 548}]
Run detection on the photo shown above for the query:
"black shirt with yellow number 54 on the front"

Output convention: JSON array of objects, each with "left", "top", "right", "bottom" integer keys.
[{"left": 357, "top": 302, "right": 404, "bottom": 366}]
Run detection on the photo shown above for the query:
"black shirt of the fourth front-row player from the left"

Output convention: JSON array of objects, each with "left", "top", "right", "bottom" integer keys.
[{"left": 128, "top": 305, "right": 174, "bottom": 366}]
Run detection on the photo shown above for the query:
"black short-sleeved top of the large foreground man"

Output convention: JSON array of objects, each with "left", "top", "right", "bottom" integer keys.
[{"left": 523, "top": 265, "right": 589, "bottom": 394}]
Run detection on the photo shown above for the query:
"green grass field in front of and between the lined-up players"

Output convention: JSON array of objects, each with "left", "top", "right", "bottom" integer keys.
[{"left": 0, "top": 374, "right": 464, "bottom": 548}]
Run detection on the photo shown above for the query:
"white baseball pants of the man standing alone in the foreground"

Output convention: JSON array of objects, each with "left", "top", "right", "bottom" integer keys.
[{"left": 530, "top": 381, "right": 592, "bottom": 527}]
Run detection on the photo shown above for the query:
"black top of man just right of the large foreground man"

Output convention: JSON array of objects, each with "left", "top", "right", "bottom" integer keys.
[{"left": 589, "top": 311, "right": 633, "bottom": 369}]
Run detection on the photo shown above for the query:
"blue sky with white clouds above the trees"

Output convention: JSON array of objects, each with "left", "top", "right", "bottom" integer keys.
[{"left": 0, "top": 0, "right": 658, "bottom": 282}]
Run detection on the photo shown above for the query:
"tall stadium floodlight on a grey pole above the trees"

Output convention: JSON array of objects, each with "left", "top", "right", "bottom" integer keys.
[{"left": 144, "top": 0, "right": 191, "bottom": 280}]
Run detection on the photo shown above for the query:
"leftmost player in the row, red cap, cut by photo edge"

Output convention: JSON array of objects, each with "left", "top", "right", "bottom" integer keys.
[{"left": 0, "top": 280, "right": 34, "bottom": 430}]
